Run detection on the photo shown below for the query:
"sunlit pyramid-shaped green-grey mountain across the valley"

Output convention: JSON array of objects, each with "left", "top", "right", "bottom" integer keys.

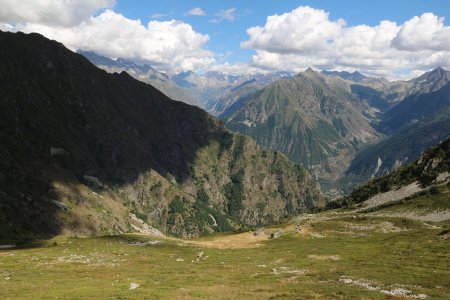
[{"left": 225, "top": 69, "right": 378, "bottom": 185}]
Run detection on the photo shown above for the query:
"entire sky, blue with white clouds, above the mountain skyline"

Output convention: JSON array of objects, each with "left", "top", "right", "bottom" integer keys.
[{"left": 0, "top": 0, "right": 450, "bottom": 79}]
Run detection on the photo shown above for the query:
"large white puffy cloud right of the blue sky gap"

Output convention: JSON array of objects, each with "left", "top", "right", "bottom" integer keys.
[{"left": 241, "top": 6, "right": 450, "bottom": 78}]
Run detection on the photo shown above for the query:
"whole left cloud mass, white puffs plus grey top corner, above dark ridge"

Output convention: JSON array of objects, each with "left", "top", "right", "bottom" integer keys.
[{"left": 0, "top": 0, "right": 214, "bottom": 71}]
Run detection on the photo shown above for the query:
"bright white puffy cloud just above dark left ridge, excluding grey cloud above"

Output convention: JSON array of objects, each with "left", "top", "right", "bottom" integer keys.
[{"left": 0, "top": 5, "right": 214, "bottom": 71}]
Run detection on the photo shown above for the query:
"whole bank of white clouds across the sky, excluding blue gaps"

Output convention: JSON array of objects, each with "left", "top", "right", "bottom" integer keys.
[{"left": 0, "top": 0, "right": 450, "bottom": 78}]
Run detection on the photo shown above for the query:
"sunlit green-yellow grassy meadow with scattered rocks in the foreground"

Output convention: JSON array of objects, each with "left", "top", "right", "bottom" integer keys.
[{"left": 0, "top": 212, "right": 450, "bottom": 299}]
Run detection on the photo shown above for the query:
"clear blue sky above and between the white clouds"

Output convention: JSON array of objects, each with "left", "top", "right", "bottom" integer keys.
[{"left": 114, "top": 0, "right": 450, "bottom": 63}]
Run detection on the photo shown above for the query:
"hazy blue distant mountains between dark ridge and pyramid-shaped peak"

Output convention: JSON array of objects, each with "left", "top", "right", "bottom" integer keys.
[{"left": 78, "top": 50, "right": 291, "bottom": 112}]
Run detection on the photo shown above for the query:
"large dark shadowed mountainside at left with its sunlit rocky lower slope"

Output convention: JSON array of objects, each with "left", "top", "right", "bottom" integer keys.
[{"left": 0, "top": 32, "right": 324, "bottom": 239}]
